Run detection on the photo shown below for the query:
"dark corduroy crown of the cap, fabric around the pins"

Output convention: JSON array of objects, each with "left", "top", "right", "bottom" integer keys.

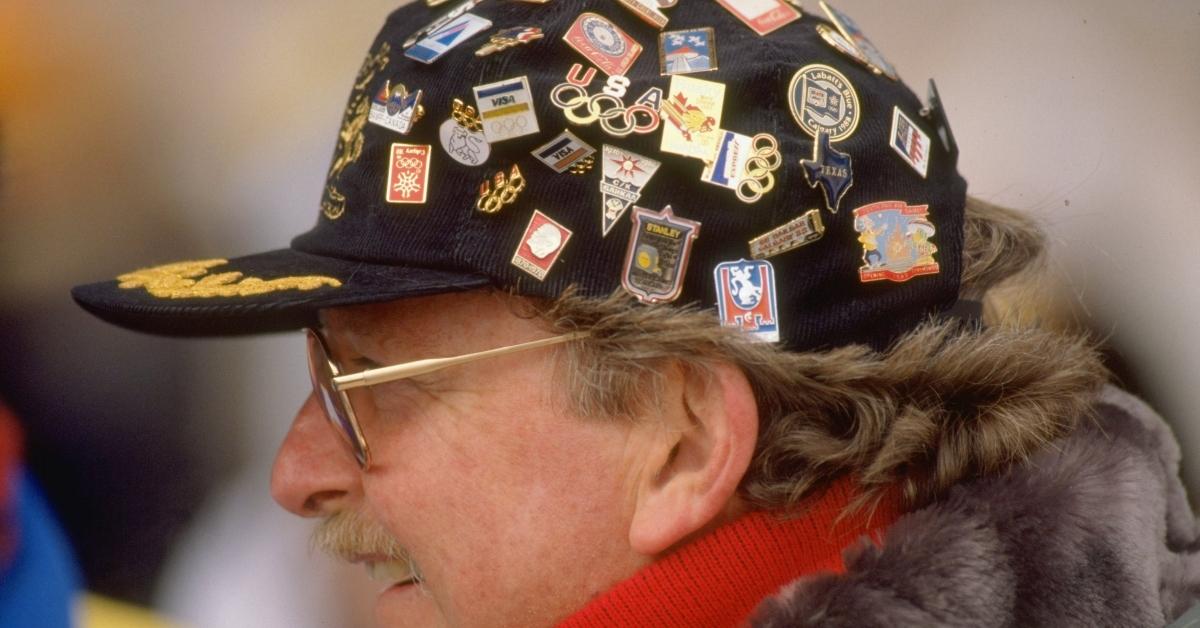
[{"left": 293, "top": 0, "right": 966, "bottom": 348}]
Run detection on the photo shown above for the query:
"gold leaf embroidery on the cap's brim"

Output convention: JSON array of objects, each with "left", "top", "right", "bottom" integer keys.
[{"left": 116, "top": 259, "right": 342, "bottom": 299}]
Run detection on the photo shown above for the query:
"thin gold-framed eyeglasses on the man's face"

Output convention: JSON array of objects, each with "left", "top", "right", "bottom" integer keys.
[{"left": 305, "top": 327, "right": 589, "bottom": 471}]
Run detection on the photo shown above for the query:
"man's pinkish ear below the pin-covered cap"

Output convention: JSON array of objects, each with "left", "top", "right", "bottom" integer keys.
[{"left": 629, "top": 363, "right": 758, "bottom": 555}]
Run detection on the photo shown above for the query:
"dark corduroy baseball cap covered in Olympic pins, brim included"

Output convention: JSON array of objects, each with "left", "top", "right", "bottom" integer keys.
[{"left": 72, "top": 0, "right": 966, "bottom": 349}]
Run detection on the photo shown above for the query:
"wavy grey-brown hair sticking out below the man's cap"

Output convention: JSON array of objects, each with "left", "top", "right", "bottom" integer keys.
[{"left": 535, "top": 198, "right": 1108, "bottom": 509}]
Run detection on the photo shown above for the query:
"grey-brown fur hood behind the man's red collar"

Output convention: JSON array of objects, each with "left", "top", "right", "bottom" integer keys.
[{"left": 752, "top": 387, "right": 1200, "bottom": 627}]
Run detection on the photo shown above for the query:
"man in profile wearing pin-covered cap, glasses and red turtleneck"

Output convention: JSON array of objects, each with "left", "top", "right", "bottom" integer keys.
[{"left": 74, "top": 0, "right": 1200, "bottom": 626}]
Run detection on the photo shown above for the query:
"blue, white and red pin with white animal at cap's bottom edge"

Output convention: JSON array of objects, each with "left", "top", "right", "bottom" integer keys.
[{"left": 713, "top": 259, "right": 779, "bottom": 342}]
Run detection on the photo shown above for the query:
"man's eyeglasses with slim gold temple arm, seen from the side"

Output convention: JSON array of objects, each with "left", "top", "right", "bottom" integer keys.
[{"left": 307, "top": 328, "right": 588, "bottom": 471}]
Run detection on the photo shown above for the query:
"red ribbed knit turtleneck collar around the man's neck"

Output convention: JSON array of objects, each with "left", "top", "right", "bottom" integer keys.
[{"left": 559, "top": 480, "right": 900, "bottom": 628}]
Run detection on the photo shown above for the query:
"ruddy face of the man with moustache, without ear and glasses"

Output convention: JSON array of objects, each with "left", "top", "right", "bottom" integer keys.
[{"left": 271, "top": 293, "right": 653, "bottom": 626}]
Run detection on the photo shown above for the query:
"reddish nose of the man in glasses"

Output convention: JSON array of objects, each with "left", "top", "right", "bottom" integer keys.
[{"left": 271, "top": 394, "right": 361, "bottom": 516}]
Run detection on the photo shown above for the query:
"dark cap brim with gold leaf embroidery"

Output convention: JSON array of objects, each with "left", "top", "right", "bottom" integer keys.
[{"left": 71, "top": 249, "right": 491, "bottom": 336}]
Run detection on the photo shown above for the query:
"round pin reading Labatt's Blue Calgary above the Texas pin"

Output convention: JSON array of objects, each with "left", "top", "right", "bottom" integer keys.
[{"left": 787, "top": 64, "right": 859, "bottom": 142}]
